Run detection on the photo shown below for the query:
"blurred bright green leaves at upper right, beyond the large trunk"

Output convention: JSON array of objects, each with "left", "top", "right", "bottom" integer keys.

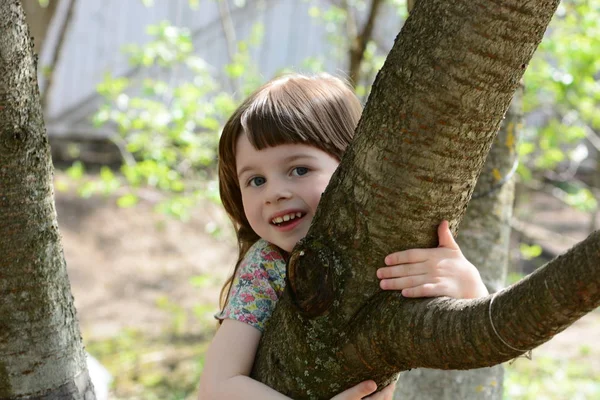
[{"left": 519, "top": 0, "right": 600, "bottom": 211}]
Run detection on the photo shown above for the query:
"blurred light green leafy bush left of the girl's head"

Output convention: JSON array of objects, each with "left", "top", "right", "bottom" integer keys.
[{"left": 69, "top": 18, "right": 260, "bottom": 218}]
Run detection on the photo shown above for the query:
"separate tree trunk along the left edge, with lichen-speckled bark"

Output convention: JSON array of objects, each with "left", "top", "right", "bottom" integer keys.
[{"left": 0, "top": 0, "right": 94, "bottom": 399}]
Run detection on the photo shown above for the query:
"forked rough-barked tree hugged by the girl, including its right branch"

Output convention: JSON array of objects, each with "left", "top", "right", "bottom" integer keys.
[{"left": 253, "top": 0, "right": 588, "bottom": 398}]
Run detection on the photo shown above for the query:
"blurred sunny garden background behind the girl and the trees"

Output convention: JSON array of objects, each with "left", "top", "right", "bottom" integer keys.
[{"left": 23, "top": 0, "right": 600, "bottom": 399}]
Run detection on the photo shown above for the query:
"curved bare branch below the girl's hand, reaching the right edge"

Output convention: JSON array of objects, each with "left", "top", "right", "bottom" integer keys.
[{"left": 356, "top": 232, "right": 600, "bottom": 370}]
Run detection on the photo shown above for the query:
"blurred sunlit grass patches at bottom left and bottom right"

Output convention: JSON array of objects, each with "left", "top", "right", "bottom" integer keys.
[{"left": 87, "top": 327, "right": 600, "bottom": 400}]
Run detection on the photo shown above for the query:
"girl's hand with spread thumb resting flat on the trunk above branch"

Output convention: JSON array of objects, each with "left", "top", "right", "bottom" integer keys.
[{"left": 377, "top": 221, "right": 489, "bottom": 299}]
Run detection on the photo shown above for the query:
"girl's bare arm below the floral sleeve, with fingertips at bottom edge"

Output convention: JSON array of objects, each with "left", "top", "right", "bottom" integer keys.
[{"left": 199, "top": 319, "right": 394, "bottom": 400}]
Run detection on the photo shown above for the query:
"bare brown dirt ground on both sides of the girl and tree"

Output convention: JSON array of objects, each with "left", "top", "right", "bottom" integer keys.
[{"left": 56, "top": 180, "right": 600, "bottom": 374}]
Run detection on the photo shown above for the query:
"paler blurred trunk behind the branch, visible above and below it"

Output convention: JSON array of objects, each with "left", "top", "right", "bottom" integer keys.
[{"left": 395, "top": 88, "right": 523, "bottom": 400}]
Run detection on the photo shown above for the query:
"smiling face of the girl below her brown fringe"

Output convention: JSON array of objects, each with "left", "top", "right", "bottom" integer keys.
[{"left": 236, "top": 134, "right": 339, "bottom": 252}]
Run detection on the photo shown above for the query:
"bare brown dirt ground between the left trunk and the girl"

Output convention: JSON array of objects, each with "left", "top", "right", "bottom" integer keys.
[{"left": 56, "top": 189, "right": 237, "bottom": 339}]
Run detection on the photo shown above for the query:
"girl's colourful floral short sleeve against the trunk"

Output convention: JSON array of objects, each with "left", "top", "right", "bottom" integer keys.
[{"left": 215, "top": 239, "right": 286, "bottom": 332}]
